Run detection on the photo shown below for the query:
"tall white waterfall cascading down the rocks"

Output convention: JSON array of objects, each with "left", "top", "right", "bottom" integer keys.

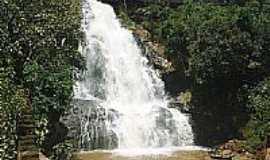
[{"left": 75, "top": 0, "right": 193, "bottom": 149}]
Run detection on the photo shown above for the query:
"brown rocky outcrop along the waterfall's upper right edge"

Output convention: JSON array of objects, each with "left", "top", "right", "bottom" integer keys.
[{"left": 131, "top": 25, "right": 193, "bottom": 97}]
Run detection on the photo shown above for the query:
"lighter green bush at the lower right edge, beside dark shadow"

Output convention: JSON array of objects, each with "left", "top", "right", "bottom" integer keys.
[{"left": 245, "top": 78, "right": 270, "bottom": 149}]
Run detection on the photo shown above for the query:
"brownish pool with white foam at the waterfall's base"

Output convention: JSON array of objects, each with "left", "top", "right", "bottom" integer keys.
[{"left": 73, "top": 146, "right": 211, "bottom": 160}]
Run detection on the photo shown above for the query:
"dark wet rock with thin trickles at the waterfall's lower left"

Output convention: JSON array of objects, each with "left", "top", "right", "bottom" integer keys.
[{"left": 61, "top": 99, "right": 120, "bottom": 150}]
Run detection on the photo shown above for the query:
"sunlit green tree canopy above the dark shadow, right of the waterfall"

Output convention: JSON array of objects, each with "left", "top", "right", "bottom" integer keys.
[{"left": 139, "top": 3, "right": 270, "bottom": 83}]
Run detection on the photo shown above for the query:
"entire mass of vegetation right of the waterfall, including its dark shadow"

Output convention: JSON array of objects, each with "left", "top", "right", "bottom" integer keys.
[{"left": 124, "top": 1, "right": 270, "bottom": 149}]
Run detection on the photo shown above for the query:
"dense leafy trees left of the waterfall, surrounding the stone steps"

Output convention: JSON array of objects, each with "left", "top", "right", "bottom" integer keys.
[{"left": 0, "top": 0, "right": 84, "bottom": 159}]
